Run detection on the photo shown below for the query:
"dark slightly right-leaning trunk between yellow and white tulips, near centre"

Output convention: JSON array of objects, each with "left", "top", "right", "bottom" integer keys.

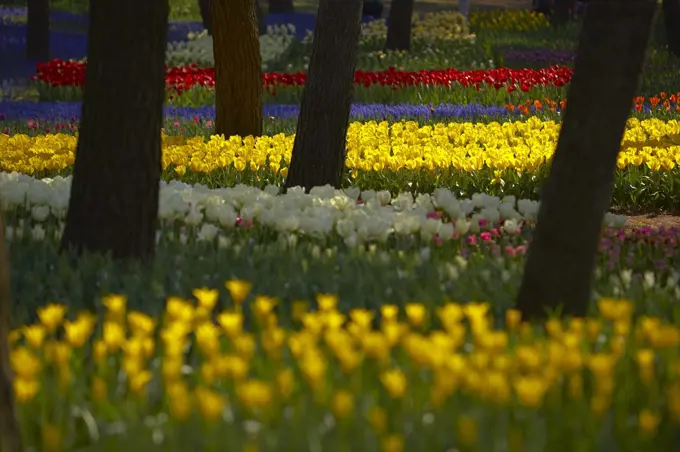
[{"left": 285, "top": 0, "right": 362, "bottom": 190}]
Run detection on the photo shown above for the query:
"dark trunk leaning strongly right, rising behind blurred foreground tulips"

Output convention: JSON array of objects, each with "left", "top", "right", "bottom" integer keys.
[{"left": 517, "top": 0, "right": 656, "bottom": 319}]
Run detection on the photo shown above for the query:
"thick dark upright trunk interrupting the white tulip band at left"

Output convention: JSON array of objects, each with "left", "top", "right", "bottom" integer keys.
[{"left": 61, "top": 0, "right": 169, "bottom": 259}]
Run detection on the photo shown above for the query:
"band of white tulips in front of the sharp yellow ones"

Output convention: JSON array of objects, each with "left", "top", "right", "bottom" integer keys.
[{"left": 0, "top": 173, "right": 626, "bottom": 245}]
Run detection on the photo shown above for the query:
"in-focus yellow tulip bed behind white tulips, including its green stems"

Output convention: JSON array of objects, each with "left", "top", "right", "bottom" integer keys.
[{"left": 0, "top": 118, "right": 680, "bottom": 213}]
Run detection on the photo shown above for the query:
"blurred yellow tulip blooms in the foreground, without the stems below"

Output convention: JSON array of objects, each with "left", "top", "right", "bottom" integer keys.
[{"left": 10, "top": 280, "right": 680, "bottom": 450}]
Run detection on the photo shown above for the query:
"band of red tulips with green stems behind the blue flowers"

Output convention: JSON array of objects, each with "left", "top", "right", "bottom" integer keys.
[{"left": 34, "top": 60, "right": 680, "bottom": 106}]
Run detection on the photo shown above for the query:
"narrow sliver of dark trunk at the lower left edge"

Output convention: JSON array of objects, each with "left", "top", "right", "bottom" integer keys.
[{"left": 0, "top": 215, "right": 23, "bottom": 452}]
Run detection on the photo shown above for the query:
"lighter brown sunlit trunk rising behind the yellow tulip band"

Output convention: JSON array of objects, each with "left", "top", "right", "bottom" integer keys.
[{"left": 212, "top": 0, "right": 262, "bottom": 138}]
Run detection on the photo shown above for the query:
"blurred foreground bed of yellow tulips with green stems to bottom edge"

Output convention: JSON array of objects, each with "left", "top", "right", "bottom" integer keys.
[{"left": 10, "top": 294, "right": 680, "bottom": 452}]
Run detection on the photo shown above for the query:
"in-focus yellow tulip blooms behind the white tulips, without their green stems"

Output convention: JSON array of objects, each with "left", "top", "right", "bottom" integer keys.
[{"left": 0, "top": 118, "right": 680, "bottom": 176}]
